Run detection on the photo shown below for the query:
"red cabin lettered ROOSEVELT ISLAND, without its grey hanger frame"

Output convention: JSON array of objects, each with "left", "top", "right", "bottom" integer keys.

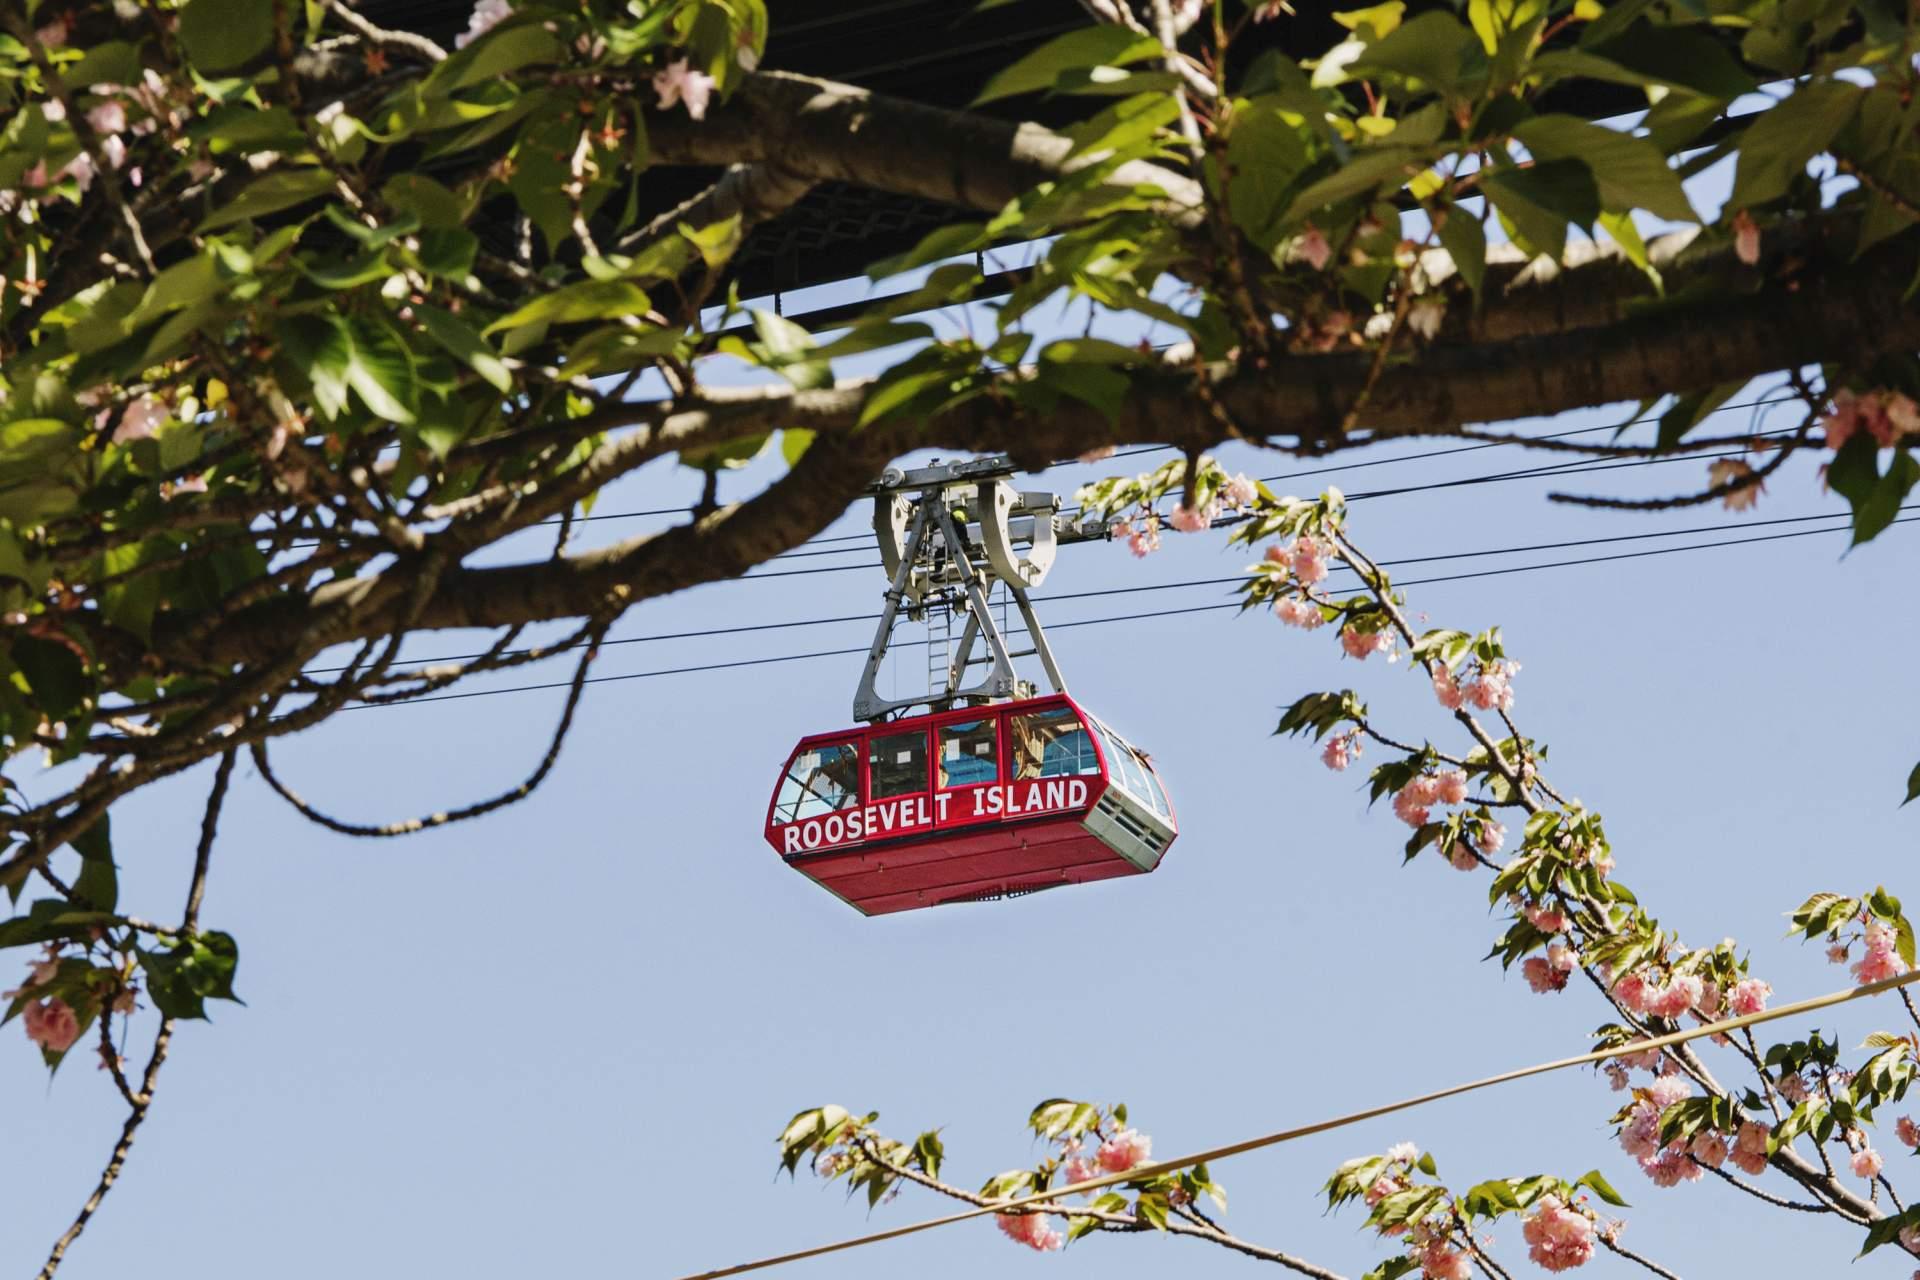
[{"left": 766, "top": 695, "right": 1177, "bottom": 915}]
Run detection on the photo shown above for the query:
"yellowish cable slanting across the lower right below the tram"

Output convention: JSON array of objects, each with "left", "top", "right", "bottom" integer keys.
[{"left": 680, "top": 969, "right": 1920, "bottom": 1280}]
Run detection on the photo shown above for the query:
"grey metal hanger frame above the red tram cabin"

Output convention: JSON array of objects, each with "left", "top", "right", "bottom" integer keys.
[{"left": 852, "top": 455, "right": 1108, "bottom": 723}]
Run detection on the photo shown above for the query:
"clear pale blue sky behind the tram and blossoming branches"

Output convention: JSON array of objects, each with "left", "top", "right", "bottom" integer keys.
[{"left": 0, "top": 119, "right": 1920, "bottom": 1280}]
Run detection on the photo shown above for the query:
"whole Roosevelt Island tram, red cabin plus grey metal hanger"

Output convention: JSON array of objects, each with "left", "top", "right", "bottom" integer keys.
[{"left": 766, "top": 457, "right": 1179, "bottom": 915}]
